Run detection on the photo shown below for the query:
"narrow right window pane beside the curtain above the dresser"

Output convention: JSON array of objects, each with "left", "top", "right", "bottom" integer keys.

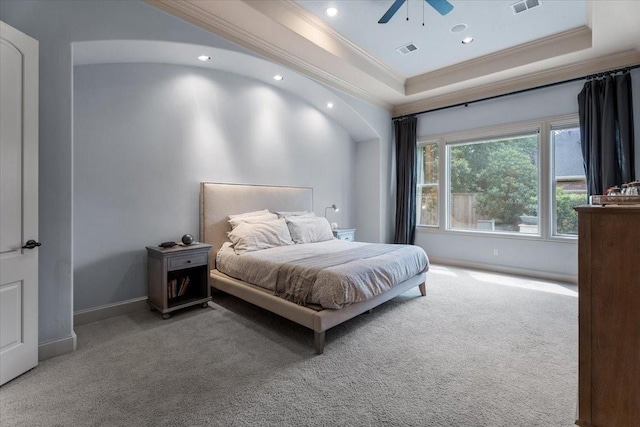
[{"left": 550, "top": 126, "right": 588, "bottom": 236}]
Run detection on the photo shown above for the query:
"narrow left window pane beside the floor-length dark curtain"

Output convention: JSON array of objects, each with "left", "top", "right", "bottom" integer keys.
[{"left": 416, "top": 143, "right": 439, "bottom": 226}]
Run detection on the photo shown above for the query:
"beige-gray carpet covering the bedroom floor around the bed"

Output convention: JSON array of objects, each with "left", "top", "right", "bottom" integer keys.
[{"left": 0, "top": 266, "right": 578, "bottom": 427}]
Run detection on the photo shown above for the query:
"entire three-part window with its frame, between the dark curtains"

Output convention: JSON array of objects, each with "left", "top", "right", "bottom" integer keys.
[{"left": 416, "top": 114, "right": 587, "bottom": 239}]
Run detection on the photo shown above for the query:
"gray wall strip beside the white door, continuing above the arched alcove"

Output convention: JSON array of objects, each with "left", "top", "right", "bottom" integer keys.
[{"left": 0, "top": 0, "right": 250, "bottom": 345}]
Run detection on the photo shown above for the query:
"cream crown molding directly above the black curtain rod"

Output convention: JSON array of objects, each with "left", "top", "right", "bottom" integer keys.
[{"left": 393, "top": 50, "right": 640, "bottom": 116}]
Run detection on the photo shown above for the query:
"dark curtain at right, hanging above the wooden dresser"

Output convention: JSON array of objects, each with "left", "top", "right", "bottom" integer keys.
[{"left": 578, "top": 72, "right": 635, "bottom": 196}]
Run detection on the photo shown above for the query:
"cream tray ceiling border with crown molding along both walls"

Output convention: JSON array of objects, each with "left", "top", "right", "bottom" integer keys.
[{"left": 144, "top": 0, "right": 640, "bottom": 115}]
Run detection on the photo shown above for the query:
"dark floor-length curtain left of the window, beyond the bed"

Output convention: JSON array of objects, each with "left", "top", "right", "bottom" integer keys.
[{"left": 393, "top": 116, "right": 418, "bottom": 245}]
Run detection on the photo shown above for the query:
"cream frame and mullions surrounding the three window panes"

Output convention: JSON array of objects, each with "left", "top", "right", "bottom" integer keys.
[{"left": 416, "top": 113, "right": 579, "bottom": 242}]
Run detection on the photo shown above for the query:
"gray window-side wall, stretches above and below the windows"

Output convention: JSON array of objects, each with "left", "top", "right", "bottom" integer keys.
[{"left": 416, "top": 69, "right": 640, "bottom": 281}]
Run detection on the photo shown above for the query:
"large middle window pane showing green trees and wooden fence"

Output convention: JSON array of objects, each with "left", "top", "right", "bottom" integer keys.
[{"left": 447, "top": 132, "right": 540, "bottom": 234}]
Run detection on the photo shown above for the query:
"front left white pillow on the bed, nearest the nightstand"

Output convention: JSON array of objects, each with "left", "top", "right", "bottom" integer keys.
[{"left": 228, "top": 218, "right": 293, "bottom": 254}]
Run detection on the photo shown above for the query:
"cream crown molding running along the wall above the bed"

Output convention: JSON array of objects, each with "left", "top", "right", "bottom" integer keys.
[{"left": 144, "top": 0, "right": 402, "bottom": 111}]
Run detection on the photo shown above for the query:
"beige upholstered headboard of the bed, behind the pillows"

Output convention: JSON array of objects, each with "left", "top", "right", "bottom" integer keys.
[{"left": 200, "top": 182, "right": 313, "bottom": 265}]
